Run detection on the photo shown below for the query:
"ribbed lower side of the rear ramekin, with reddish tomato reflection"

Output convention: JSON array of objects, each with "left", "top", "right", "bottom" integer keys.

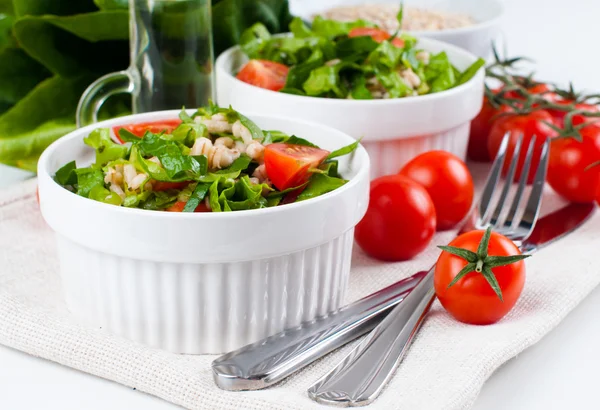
[{"left": 362, "top": 123, "right": 470, "bottom": 179}]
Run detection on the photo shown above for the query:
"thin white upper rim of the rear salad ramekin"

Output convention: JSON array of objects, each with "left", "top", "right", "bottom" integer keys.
[{"left": 215, "top": 33, "right": 485, "bottom": 106}]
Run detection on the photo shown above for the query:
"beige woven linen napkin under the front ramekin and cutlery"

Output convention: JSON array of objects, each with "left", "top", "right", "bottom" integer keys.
[{"left": 0, "top": 177, "right": 600, "bottom": 410}]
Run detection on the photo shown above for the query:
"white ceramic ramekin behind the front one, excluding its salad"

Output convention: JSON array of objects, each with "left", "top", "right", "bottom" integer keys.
[{"left": 216, "top": 39, "right": 484, "bottom": 178}]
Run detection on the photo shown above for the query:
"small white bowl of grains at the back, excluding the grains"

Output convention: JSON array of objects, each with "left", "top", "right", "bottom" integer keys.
[{"left": 290, "top": 0, "right": 504, "bottom": 59}]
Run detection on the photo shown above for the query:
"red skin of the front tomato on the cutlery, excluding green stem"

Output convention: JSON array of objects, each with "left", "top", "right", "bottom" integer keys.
[{"left": 434, "top": 231, "right": 525, "bottom": 325}]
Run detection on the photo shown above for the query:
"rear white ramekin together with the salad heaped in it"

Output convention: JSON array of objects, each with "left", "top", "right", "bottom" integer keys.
[{"left": 215, "top": 17, "right": 485, "bottom": 178}]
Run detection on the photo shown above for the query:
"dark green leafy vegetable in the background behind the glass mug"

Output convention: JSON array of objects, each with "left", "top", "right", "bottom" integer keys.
[{"left": 0, "top": 0, "right": 291, "bottom": 169}]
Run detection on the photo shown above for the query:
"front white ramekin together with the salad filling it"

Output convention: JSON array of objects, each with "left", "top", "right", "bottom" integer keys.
[{"left": 38, "top": 105, "right": 369, "bottom": 354}]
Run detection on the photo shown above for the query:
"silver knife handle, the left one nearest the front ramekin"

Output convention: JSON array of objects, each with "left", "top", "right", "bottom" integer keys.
[{"left": 212, "top": 272, "right": 426, "bottom": 391}]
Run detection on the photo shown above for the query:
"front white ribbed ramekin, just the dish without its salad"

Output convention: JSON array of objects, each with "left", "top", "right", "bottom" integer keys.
[{"left": 38, "top": 111, "right": 369, "bottom": 354}]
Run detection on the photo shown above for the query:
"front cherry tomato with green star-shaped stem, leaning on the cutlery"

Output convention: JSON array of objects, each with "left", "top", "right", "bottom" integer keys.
[{"left": 434, "top": 226, "right": 527, "bottom": 325}]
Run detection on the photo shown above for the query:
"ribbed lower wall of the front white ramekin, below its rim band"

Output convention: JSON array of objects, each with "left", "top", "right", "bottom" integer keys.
[{"left": 58, "top": 230, "right": 354, "bottom": 354}]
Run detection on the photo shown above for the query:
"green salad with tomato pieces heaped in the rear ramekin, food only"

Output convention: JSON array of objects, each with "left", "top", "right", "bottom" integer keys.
[{"left": 237, "top": 14, "right": 485, "bottom": 100}]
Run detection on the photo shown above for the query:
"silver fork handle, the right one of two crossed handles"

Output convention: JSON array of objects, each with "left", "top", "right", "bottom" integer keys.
[{"left": 308, "top": 268, "right": 435, "bottom": 407}]
